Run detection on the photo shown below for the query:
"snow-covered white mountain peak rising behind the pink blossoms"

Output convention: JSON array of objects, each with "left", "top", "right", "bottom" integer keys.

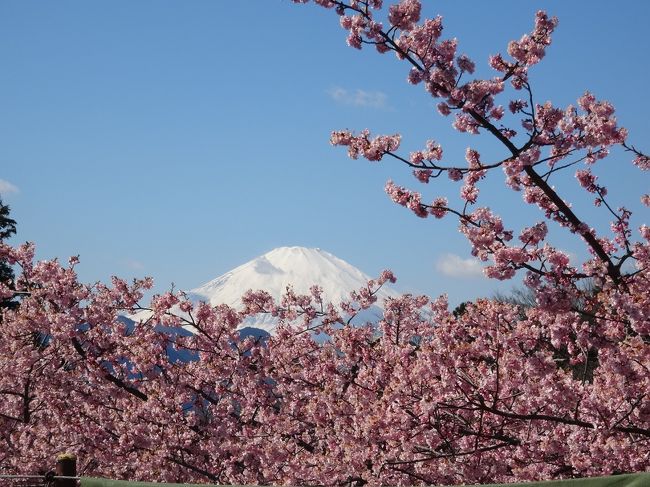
[{"left": 132, "top": 247, "right": 398, "bottom": 334}]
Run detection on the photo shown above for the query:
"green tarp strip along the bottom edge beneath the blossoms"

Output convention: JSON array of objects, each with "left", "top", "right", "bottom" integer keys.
[{"left": 81, "top": 473, "right": 650, "bottom": 487}]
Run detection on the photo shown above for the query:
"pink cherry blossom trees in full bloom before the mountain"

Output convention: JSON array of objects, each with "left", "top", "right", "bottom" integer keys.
[{"left": 0, "top": 0, "right": 650, "bottom": 485}]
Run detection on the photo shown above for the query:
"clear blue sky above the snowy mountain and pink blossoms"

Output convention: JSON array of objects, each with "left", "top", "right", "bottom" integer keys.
[{"left": 0, "top": 0, "right": 650, "bottom": 302}]
